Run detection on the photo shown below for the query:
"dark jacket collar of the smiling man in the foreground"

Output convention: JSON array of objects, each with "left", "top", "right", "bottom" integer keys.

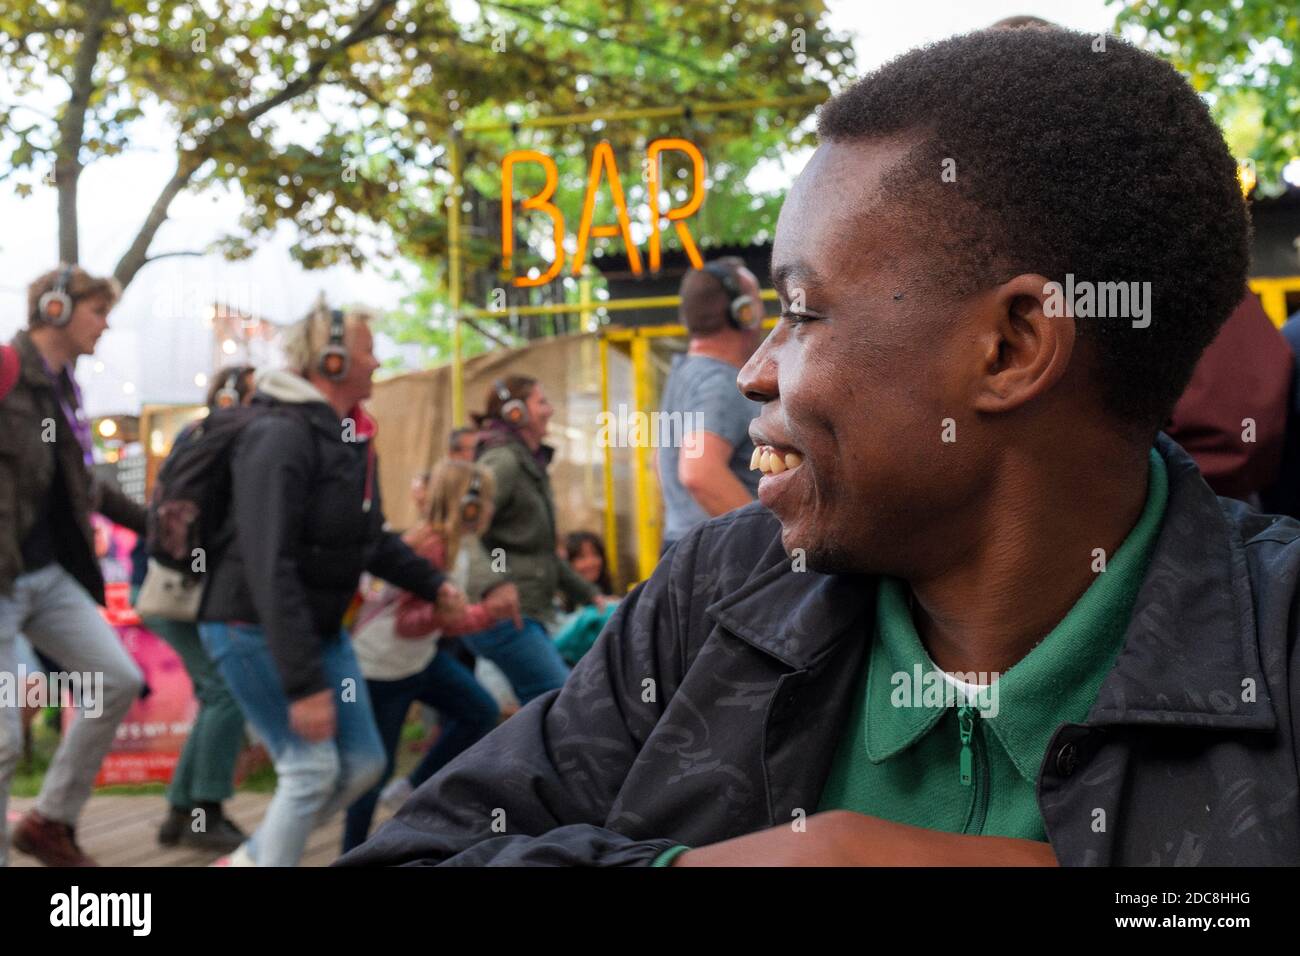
[{"left": 706, "top": 434, "right": 1277, "bottom": 730}]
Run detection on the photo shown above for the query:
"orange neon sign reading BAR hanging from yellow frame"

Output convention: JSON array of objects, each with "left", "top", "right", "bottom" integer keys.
[{"left": 501, "top": 139, "right": 705, "bottom": 286}]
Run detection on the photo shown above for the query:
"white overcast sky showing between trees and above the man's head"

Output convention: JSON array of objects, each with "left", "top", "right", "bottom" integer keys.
[{"left": 0, "top": 0, "right": 1117, "bottom": 415}]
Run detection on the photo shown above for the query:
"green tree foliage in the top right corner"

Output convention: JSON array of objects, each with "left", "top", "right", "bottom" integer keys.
[{"left": 1115, "top": 0, "right": 1300, "bottom": 194}]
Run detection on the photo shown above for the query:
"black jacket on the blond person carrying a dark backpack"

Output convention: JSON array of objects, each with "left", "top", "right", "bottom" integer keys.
[{"left": 199, "top": 372, "right": 446, "bottom": 700}]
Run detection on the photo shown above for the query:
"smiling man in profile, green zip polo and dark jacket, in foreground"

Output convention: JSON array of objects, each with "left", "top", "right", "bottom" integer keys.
[{"left": 346, "top": 30, "right": 1300, "bottom": 865}]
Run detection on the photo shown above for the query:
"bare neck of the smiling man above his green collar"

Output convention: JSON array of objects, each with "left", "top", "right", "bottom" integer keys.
[{"left": 910, "top": 431, "right": 1149, "bottom": 674}]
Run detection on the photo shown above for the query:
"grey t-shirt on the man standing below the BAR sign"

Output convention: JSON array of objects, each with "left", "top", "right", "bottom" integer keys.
[{"left": 659, "top": 355, "right": 762, "bottom": 544}]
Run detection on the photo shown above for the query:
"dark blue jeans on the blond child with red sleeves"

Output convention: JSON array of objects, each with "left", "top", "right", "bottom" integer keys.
[{"left": 343, "top": 653, "right": 501, "bottom": 853}]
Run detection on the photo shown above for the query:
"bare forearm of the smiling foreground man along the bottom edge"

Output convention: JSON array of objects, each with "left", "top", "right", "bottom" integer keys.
[{"left": 672, "top": 810, "right": 1058, "bottom": 866}]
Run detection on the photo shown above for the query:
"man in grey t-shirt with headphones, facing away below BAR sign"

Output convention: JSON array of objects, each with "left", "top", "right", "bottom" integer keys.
[{"left": 657, "top": 256, "right": 763, "bottom": 550}]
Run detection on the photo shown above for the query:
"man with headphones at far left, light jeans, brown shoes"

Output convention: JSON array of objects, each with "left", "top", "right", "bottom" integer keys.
[{"left": 0, "top": 265, "right": 144, "bottom": 866}]
